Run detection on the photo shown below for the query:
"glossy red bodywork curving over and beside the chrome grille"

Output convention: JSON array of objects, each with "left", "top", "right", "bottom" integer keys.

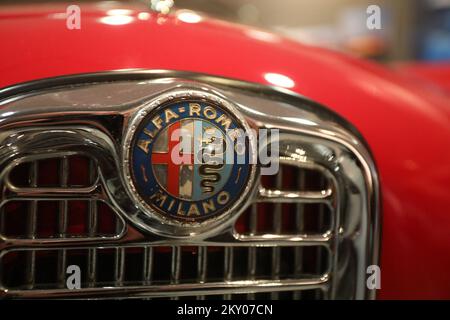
[{"left": 0, "top": 3, "right": 450, "bottom": 299}]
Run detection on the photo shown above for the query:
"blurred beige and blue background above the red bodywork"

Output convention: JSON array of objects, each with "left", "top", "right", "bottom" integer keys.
[{"left": 172, "top": 0, "right": 450, "bottom": 62}]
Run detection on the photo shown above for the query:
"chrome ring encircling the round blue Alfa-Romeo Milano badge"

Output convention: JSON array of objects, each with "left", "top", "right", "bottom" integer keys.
[{"left": 122, "top": 84, "right": 256, "bottom": 238}]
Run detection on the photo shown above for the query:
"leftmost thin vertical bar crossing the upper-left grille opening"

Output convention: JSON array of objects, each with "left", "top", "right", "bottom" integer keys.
[{"left": 25, "top": 161, "right": 38, "bottom": 289}]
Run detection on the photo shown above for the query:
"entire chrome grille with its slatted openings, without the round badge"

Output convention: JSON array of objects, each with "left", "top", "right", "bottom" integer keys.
[{"left": 0, "top": 72, "right": 378, "bottom": 299}]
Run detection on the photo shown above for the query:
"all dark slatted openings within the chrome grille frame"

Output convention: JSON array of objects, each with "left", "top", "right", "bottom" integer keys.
[{"left": 0, "top": 156, "right": 332, "bottom": 299}]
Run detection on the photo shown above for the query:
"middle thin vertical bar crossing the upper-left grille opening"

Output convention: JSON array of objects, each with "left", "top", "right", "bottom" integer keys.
[{"left": 58, "top": 157, "right": 69, "bottom": 287}]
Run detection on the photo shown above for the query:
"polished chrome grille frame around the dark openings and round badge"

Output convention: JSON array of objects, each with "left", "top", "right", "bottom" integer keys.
[{"left": 0, "top": 70, "right": 380, "bottom": 299}]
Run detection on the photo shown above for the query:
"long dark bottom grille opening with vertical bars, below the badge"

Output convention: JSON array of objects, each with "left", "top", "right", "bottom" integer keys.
[{"left": 1, "top": 246, "right": 328, "bottom": 296}]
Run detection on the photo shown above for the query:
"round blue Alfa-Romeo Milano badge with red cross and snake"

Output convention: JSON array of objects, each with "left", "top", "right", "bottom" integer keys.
[{"left": 124, "top": 90, "right": 255, "bottom": 234}]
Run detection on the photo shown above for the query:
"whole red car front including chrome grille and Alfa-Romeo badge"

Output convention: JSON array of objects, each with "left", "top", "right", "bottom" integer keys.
[{"left": 0, "top": 2, "right": 450, "bottom": 299}]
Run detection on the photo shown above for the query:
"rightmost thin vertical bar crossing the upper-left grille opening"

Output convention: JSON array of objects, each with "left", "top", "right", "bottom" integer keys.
[{"left": 87, "top": 159, "right": 98, "bottom": 287}]
